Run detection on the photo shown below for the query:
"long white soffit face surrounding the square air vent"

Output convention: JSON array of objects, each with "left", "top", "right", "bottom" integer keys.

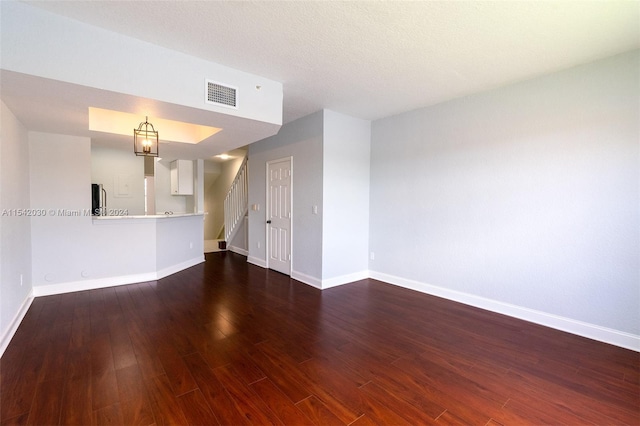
[{"left": 0, "top": 1, "right": 282, "bottom": 125}]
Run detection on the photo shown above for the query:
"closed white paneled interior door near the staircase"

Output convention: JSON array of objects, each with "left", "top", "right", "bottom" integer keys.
[{"left": 267, "top": 158, "right": 292, "bottom": 275}]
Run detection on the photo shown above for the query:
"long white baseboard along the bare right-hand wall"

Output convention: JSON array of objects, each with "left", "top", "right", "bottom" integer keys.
[{"left": 369, "top": 271, "right": 640, "bottom": 352}]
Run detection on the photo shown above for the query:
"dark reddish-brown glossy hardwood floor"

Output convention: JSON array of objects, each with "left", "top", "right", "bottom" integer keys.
[{"left": 0, "top": 252, "right": 640, "bottom": 425}]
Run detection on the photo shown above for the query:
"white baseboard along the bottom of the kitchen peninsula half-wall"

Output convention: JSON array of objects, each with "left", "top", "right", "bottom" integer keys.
[{"left": 33, "top": 256, "right": 204, "bottom": 297}]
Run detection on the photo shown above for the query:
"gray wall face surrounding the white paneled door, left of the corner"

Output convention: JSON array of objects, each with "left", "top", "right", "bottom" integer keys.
[{"left": 248, "top": 111, "right": 323, "bottom": 286}]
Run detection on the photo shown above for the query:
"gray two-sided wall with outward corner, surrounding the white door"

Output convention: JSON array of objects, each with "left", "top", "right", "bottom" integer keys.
[{"left": 249, "top": 110, "right": 371, "bottom": 288}]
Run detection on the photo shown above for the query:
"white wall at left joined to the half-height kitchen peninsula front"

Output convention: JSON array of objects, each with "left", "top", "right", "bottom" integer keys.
[{"left": 29, "top": 132, "right": 204, "bottom": 296}]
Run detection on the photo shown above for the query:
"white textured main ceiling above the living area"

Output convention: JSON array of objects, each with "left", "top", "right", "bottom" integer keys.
[{"left": 22, "top": 0, "right": 640, "bottom": 122}]
